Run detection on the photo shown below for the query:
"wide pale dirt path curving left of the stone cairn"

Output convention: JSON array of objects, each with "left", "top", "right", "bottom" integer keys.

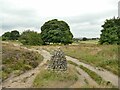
[{"left": 2, "top": 47, "right": 50, "bottom": 88}]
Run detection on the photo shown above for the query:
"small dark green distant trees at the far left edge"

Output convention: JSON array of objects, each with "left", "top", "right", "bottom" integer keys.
[{"left": 2, "top": 30, "right": 20, "bottom": 41}]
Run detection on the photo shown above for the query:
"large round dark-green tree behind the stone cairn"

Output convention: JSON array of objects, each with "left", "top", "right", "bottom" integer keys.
[{"left": 41, "top": 19, "right": 73, "bottom": 44}]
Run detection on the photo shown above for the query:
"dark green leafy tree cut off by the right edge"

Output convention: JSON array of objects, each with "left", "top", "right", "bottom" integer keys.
[{"left": 99, "top": 18, "right": 120, "bottom": 44}]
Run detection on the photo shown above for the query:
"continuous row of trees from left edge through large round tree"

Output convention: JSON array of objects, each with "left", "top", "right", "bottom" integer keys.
[{"left": 2, "top": 19, "right": 73, "bottom": 45}]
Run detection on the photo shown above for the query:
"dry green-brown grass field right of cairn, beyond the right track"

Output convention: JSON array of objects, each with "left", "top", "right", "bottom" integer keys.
[{"left": 61, "top": 44, "right": 120, "bottom": 75}]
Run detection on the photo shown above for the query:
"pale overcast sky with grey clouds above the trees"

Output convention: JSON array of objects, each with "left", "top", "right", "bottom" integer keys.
[{"left": 0, "top": 0, "right": 119, "bottom": 38}]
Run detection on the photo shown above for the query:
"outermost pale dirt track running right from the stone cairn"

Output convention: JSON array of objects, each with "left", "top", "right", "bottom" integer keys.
[{"left": 66, "top": 56, "right": 118, "bottom": 87}]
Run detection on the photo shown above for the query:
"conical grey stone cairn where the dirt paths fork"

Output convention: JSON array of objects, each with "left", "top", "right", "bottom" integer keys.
[{"left": 48, "top": 48, "right": 67, "bottom": 71}]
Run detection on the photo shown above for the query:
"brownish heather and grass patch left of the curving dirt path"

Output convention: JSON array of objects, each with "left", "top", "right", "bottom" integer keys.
[{"left": 2, "top": 43, "right": 43, "bottom": 80}]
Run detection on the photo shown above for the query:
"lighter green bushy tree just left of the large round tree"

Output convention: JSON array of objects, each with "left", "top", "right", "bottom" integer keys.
[{"left": 19, "top": 30, "right": 43, "bottom": 45}]
